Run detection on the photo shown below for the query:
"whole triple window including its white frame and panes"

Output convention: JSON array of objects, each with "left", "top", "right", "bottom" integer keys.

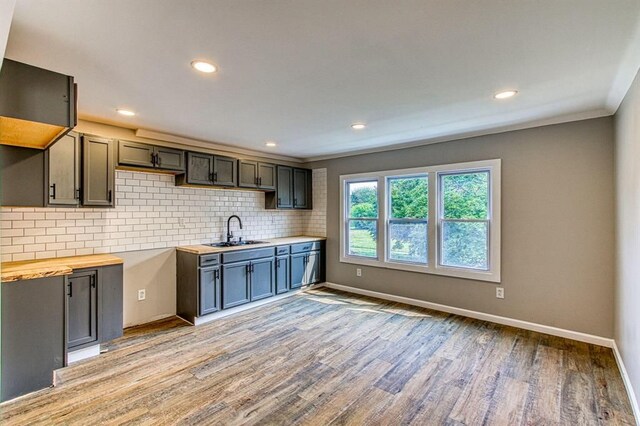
[{"left": 340, "top": 160, "right": 500, "bottom": 282}]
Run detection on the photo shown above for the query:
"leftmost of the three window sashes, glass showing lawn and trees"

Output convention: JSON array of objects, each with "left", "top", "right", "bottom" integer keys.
[{"left": 347, "top": 181, "right": 378, "bottom": 258}]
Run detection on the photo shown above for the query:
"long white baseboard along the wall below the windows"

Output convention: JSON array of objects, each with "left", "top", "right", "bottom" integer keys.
[{"left": 325, "top": 282, "right": 614, "bottom": 348}]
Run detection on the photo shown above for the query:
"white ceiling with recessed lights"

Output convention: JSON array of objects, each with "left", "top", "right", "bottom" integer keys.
[{"left": 6, "top": 0, "right": 640, "bottom": 158}]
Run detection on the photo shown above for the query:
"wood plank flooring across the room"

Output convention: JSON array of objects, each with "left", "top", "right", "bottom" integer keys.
[{"left": 0, "top": 289, "right": 634, "bottom": 425}]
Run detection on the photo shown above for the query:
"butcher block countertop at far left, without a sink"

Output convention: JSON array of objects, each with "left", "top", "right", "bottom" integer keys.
[{"left": 1, "top": 254, "right": 123, "bottom": 283}]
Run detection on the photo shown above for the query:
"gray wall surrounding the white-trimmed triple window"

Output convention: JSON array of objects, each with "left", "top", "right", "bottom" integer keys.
[{"left": 309, "top": 117, "right": 614, "bottom": 337}]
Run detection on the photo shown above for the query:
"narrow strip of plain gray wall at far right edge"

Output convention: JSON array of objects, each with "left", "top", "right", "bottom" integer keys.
[{"left": 615, "top": 68, "right": 640, "bottom": 405}]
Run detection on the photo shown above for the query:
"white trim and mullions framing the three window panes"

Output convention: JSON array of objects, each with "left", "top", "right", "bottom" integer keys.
[{"left": 340, "top": 159, "right": 501, "bottom": 283}]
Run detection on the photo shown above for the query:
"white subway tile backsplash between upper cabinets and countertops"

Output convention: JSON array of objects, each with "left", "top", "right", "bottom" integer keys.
[{"left": 0, "top": 169, "right": 327, "bottom": 262}]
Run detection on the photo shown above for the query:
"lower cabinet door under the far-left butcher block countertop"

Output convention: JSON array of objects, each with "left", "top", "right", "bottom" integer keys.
[{"left": 67, "top": 271, "right": 98, "bottom": 349}]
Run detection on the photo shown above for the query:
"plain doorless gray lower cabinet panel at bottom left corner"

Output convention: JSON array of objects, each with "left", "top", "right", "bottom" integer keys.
[{"left": 0, "top": 276, "right": 66, "bottom": 401}]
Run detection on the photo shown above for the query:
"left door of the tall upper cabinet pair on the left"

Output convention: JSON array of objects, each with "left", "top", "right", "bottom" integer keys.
[{"left": 47, "top": 133, "right": 80, "bottom": 206}]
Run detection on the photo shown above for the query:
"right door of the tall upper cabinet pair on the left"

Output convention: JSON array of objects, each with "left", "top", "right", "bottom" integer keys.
[{"left": 82, "top": 136, "right": 115, "bottom": 207}]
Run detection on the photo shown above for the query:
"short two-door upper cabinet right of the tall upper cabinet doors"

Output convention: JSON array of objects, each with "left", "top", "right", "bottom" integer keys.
[{"left": 118, "top": 140, "right": 185, "bottom": 172}]
